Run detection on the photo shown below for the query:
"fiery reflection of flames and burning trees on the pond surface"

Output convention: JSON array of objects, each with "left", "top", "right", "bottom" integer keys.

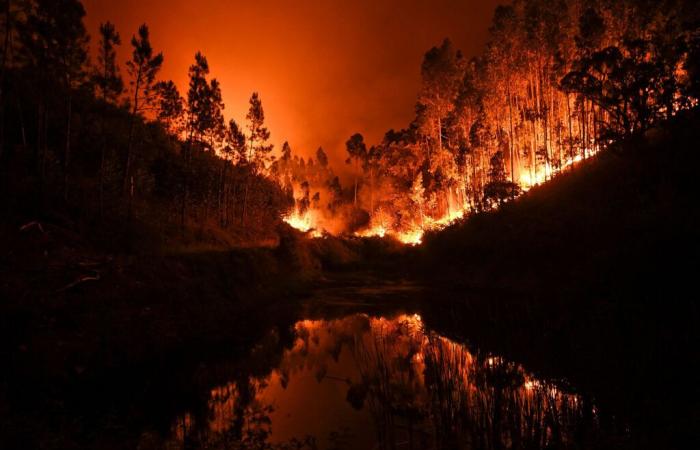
[{"left": 168, "top": 314, "right": 598, "bottom": 448}]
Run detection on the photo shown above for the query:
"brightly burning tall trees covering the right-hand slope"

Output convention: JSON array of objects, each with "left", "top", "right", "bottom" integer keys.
[{"left": 324, "top": 0, "right": 700, "bottom": 242}]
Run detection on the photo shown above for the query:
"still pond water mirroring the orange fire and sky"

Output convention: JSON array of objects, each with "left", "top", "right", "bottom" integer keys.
[{"left": 161, "top": 313, "right": 598, "bottom": 449}]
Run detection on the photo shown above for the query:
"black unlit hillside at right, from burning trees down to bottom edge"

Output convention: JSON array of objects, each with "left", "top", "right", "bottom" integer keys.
[{"left": 414, "top": 111, "right": 700, "bottom": 448}]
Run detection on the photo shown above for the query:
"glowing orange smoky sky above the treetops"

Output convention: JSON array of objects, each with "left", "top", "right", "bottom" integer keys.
[{"left": 83, "top": 0, "right": 499, "bottom": 162}]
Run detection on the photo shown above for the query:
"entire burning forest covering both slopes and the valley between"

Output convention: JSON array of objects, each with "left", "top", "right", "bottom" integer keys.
[{"left": 0, "top": 0, "right": 700, "bottom": 245}]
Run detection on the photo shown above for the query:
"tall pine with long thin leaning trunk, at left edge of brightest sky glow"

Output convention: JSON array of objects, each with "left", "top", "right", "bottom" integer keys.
[{"left": 124, "top": 24, "right": 163, "bottom": 197}]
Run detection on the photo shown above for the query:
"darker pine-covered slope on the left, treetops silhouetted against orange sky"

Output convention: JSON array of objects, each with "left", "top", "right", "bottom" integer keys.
[{"left": 0, "top": 0, "right": 290, "bottom": 250}]
